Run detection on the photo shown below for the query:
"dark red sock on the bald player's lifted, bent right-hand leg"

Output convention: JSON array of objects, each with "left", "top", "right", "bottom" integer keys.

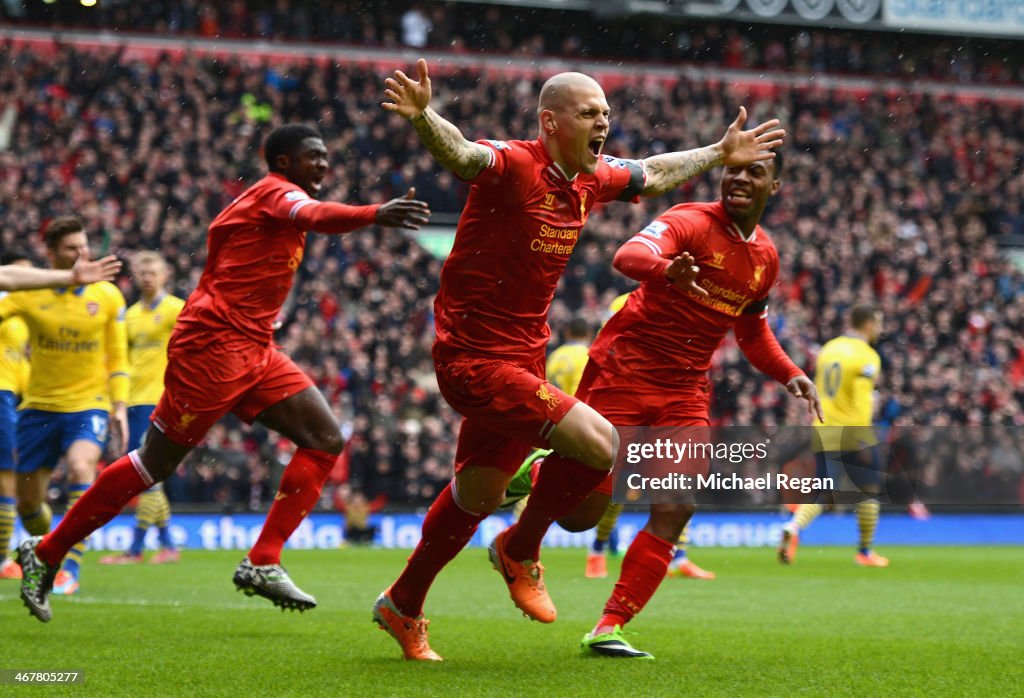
[{"left": 505, "top": 453, "right": 608, "bottom": 561}]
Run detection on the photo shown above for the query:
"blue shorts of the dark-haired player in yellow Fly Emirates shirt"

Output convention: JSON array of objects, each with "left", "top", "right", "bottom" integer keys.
[{"left": 15, "top": 409, "right": 111, "bottom": 473}]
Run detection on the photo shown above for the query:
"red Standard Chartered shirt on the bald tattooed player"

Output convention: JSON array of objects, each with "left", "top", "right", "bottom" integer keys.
[{"left": 434, "top": 140, "right": 644, "bottom": 363}]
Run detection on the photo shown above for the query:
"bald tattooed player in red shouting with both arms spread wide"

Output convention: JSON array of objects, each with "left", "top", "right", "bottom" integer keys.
[{"left": 374, "top": 58, "right": 784, "bottom": 660}]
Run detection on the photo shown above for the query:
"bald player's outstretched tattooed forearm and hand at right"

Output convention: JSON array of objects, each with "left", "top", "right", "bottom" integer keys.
[{"left": 641, "top": 106, "right": 785, "bottom": 197}]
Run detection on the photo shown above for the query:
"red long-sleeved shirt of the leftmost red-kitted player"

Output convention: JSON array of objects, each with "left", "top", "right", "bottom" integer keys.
[{"left": 177, "top": 172, "right": 379, "bottom": 345}]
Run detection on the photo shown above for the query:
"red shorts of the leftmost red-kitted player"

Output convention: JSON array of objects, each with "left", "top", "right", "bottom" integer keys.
[{"left": 153, "top": 332, "right": 313, "bottom": 446}]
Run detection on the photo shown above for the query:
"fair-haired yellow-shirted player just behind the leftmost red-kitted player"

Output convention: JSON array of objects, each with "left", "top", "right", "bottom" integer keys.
[{"left": 99, "top": 252, "right": 185, "bottom": 565}]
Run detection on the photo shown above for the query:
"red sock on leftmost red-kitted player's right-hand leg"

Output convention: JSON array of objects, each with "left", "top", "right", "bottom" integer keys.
[{"left": 249, "top": 448, "right": 338, "bottom": 565}]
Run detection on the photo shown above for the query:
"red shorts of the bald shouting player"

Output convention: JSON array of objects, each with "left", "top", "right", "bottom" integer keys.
[{"left": 434, "top": 357, "right": 580, "bottom": 475}]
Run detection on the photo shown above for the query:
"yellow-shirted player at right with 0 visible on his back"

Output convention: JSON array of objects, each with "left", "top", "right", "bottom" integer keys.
[{"left": 778, "top": 305, "right": 889, "bottom": 567}]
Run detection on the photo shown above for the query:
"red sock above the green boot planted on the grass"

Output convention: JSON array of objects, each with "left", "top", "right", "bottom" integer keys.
[{"left": 597, "top": 531, "right": 675, "bottom": 627}]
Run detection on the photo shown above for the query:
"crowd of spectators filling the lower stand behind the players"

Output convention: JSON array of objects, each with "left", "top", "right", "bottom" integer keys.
[{"left": 0, "top": 38, "right": 1024, "bottom": 508}]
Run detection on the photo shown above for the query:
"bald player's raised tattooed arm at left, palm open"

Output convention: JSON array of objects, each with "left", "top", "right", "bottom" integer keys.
[{"left": 381, "top": 58, "right": 490, "bottom": 179}]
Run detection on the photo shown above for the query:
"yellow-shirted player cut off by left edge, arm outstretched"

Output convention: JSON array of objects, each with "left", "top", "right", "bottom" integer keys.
[{"left": 0, "top": 251, "right": 121, "bottom": 579}]
